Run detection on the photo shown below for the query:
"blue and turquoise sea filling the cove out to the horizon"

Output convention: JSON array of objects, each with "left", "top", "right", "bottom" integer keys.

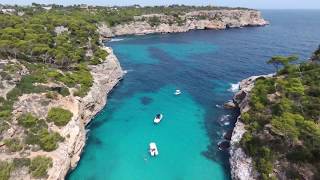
[{"left": 67, "top": 10, "right": 320, "bottom": 180}]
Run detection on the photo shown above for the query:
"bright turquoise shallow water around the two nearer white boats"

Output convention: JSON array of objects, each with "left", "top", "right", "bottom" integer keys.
[{"left": 78, "top": 86, "right": 224, "bottom": 180}]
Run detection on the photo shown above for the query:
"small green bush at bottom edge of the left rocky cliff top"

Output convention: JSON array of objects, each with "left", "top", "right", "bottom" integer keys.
[{"left": 29, "top": 156, "right": 52, "bottom": 178}]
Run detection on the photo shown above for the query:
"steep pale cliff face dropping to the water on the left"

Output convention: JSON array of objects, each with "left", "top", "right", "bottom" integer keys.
[{"left": 48, "top": 47, "right": 124, "bottom": 180}]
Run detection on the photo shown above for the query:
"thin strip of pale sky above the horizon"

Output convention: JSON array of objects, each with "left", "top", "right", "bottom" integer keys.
[{"left": 0, "top": 0, "right": 320, "bottom": 9}]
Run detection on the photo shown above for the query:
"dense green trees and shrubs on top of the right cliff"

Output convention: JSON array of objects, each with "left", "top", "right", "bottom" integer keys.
[{"left": 241, "top": 52, "right": 320, "bottom": 179}]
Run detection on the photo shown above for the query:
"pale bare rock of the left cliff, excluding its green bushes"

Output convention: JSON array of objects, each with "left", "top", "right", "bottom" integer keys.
[{"left": 0, "top": 47, "right": 123, "bottom": 180}]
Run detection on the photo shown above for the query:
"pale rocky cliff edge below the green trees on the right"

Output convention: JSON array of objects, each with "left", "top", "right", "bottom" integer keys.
[{"left": 230, "top": 74, "right": 273, "bottom": 180}]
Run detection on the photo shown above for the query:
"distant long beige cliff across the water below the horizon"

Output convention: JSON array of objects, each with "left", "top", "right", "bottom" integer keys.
[{"left": 99, "top": 9, "right": 268, "bottom": 38}]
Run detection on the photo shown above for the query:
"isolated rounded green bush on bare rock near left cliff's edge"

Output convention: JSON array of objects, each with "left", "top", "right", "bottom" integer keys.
[{"left": 47, "top": 107, "right": 73, "bottom": 126}]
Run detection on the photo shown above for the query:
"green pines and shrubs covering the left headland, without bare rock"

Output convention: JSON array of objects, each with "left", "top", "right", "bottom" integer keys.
[{"left": 0, "top": 3, "right": 255, "bottom": 179}]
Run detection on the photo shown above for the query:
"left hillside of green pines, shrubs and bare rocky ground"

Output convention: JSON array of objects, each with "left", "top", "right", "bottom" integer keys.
[{"left": 0, "top": 4, "right": 251, "bottom": 179}]
